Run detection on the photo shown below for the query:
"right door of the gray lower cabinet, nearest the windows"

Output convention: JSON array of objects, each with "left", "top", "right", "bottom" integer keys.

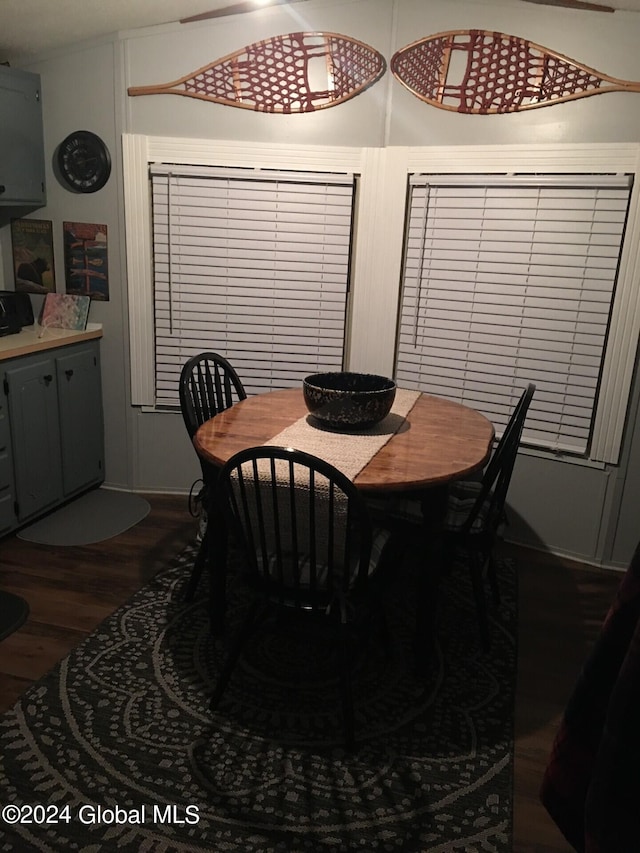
[{"left": 56, "top": 344, "right": 104, "bottom": 497}]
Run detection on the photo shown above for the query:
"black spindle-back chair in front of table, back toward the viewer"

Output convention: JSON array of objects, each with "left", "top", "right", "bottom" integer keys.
[{"left": 210, "top": 446, "right": 389, "bottom": 749}]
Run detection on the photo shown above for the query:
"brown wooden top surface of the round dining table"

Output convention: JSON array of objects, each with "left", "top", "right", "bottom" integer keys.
[{"left": 194, "top": 388, "right": 494, "bottom": 492}]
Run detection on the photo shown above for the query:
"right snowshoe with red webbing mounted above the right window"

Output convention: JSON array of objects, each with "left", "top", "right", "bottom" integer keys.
[{"left": 391, "top": 30, "right": 640, "bottom": 115}]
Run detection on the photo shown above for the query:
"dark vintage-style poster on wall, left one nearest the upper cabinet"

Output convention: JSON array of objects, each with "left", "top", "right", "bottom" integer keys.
[{"left": 11, "top": 219, "right": 56, "bottom": 294}]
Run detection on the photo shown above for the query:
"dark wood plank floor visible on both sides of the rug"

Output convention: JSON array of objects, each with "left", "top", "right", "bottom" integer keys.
[{"left": 0, "top": 495, "right": 621, "bottom": 853}]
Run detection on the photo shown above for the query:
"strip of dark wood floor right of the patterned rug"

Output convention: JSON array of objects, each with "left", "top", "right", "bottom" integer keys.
[{"left": 503, "top": 547, "right": 622, "bottom": 853}]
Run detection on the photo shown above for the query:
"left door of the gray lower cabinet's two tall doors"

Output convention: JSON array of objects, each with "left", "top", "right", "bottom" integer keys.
[{"left": 5, "top": 356, "right": 62, "bottom": 521}]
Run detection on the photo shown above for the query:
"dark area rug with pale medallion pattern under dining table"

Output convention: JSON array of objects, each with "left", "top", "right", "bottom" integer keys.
[{"left": 0, "top": 548, "right": 517, "bottom": 853}]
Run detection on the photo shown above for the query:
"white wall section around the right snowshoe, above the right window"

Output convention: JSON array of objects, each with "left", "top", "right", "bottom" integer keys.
[{"left": 389, "top": 0, "right": 640, "bottom": 145}]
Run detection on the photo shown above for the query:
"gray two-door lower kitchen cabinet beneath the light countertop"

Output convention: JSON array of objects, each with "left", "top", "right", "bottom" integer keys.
[{"left": 0, "top": 341, "right": 104, "bottom": 525}]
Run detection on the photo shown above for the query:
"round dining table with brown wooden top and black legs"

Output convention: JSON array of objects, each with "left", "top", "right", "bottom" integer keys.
[{"left": 194, "top": 388, "right": 494, "bottom": 662}]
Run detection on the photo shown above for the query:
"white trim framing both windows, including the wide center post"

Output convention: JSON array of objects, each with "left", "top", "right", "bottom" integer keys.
[{"left": 123, "top": 134, "right": 640, "bottom": 462}]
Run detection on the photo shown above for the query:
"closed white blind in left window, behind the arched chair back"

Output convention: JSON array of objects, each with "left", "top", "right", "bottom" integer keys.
[{"left": 151, "top": 166, "right": 354, "bottom": 406}]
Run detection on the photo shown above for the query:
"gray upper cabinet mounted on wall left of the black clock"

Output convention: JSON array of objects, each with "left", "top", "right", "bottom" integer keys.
[{"left": 0, "top": 66, "right": 47, "bottom": 224}]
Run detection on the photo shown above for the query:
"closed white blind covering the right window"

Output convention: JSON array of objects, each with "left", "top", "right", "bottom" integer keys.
[{"left": 395, "top": 176, "right": 630, "bottom": 454}]
